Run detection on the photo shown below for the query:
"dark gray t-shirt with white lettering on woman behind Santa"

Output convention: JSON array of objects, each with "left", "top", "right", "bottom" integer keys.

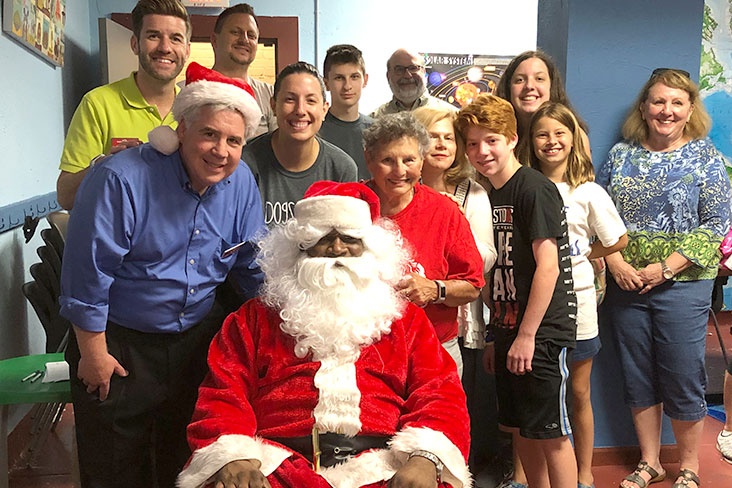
[{"left": 241, "top": 133, "right": 357, "bottom": 227}]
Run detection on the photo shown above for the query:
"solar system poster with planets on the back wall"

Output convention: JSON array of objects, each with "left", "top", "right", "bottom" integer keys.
[{"left": 423, "top": 53, "right": 513, "bottom": 108}]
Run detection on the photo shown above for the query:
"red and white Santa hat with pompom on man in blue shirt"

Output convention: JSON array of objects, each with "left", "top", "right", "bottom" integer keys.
[{"left": 148, "top": 62, "right": 262, "bottom": 154}]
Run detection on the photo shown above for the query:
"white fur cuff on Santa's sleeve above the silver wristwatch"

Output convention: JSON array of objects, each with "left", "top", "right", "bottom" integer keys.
[{"left": 389, "top": 427, "right": 473, "bottom": 488}]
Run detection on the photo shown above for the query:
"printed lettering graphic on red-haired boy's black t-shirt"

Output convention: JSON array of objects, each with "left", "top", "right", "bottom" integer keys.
[{"left": 490, "top": 205, "right": 518, "bottom": 328}]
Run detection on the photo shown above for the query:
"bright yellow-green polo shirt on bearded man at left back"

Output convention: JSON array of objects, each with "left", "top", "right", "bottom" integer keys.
[{"left": 59, "top": 71, "right": 180, "bottom": 173}]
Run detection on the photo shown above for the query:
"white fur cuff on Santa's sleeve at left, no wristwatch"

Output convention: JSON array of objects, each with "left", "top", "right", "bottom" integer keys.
[{"left": 176, "top": 435, "right": 292, "bottom": 488}]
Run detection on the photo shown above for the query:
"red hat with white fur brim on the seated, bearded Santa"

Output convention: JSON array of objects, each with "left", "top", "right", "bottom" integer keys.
[{"left": 295, "top": 181, "right": 380, "bottom": 230}]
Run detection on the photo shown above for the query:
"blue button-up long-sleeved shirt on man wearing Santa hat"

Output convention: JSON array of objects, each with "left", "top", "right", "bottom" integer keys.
[{"left": 60, "top": 144, "right": 264, "bottom": 333}]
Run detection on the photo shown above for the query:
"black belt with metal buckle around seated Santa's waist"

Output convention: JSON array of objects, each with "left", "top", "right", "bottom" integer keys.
[{"left": 268, "top": 428, "right": 389, "bottom": 471}]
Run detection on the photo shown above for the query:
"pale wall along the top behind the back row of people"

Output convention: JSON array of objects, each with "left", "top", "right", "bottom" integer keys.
[{"left": 90, "top": 0, "right": 538, "bottom": 112}]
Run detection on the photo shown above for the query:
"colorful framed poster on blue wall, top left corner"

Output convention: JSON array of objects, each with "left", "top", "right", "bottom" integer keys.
[{"left": 3, "top": 0, "right": 66, "bottom": 66}]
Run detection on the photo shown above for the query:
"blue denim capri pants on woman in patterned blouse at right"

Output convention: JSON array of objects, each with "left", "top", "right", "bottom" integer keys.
[{"left": 605, "top": 279, "right": 714, "bottom": 421}]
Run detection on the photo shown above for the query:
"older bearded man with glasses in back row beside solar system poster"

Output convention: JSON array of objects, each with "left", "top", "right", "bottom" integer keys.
[{"left": 371, "top": 48, "right": 457, "bottom": 117}]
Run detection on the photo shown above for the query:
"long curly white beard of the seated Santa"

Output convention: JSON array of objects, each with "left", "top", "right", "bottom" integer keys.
[{"left": 265, "top": 251, "right": 404, "bottom": 361}]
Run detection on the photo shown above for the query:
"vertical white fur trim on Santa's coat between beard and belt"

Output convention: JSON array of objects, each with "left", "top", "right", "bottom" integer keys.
[{"left": 313, "top": 357, "right": 361, "bottom": 436}]
